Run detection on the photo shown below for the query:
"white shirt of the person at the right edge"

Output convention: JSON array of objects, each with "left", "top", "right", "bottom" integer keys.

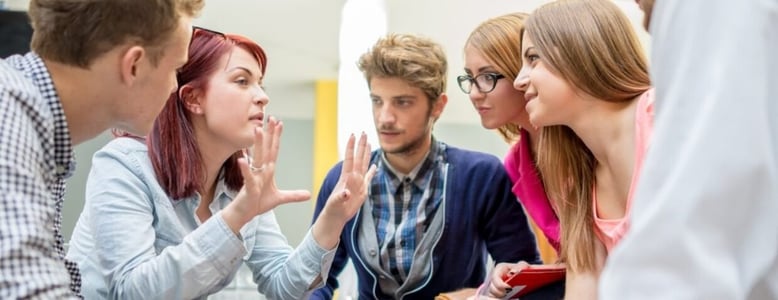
[{"left": 600, "top": 0, "right": 778, "bottom": 300}]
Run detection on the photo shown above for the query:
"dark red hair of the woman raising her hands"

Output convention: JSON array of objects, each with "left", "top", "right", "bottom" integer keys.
[{"left": 146, "top": 29, "right": 267, "bottom": 200}]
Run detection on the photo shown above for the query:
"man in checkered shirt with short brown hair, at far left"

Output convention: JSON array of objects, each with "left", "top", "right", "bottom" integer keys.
[{"left": 0, "top": 0, "right": 203, "bottom": 299}]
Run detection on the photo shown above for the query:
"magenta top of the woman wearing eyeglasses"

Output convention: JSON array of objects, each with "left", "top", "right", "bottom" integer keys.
[{"left": 504, "top": 129, "right": 559, "bottom": 253}]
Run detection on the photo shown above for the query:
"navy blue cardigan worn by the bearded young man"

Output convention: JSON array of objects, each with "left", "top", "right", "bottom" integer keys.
[{"left": 311, "top": 146, "right": 541, "bottom": 299}]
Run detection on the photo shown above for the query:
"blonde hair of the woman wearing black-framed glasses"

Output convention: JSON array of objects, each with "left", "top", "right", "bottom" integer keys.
[{"left": 465, "top": 13, "right": 529, "bottom": 143}]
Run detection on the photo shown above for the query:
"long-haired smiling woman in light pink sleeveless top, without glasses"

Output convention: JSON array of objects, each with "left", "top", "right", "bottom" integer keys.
[{"left": 489, "top": 0, "right": 653, "bottom": 299}]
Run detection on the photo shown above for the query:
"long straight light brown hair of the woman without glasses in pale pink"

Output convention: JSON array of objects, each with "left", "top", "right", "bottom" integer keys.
[{"left": 524, "top": 0, "right": 650, "bottom": 271}]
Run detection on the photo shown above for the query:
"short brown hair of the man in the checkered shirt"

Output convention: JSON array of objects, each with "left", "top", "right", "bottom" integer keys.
[{"left": 29, "top": 0, "right": 204, "bottom": 68}]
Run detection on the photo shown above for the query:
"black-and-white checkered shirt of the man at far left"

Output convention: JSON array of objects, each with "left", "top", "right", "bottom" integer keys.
[{"left": 0, "top": 53, "right": 81, "bottom": 299}]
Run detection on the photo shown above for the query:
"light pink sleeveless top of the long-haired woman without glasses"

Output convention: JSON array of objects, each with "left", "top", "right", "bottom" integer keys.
[{"left": 592, "top": 89, "right": 654, "bottom": 253}]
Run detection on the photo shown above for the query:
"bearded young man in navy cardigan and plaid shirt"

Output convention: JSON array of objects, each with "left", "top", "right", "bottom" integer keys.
[{"left": 312, "top": 34, "right": 540, "bottom": 299}]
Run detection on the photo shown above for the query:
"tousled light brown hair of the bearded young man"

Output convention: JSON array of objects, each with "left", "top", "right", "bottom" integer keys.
[{"left": 358, "top": 33, "right": 448, "bottom": 101}]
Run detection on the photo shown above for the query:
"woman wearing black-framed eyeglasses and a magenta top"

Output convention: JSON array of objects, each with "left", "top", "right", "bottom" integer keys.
[{"left": 457, "top": 13, "right": 564, "bottom": 298}]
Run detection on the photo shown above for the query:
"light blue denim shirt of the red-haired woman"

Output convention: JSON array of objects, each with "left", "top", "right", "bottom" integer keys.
[{"left": 67, "top": 138, "right": 337, "bottom": 300}]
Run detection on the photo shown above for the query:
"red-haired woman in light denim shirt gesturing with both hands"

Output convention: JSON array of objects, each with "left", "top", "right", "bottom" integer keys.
[{"left": 68, "top": 28, "right": 374, "bottom": 299}]
